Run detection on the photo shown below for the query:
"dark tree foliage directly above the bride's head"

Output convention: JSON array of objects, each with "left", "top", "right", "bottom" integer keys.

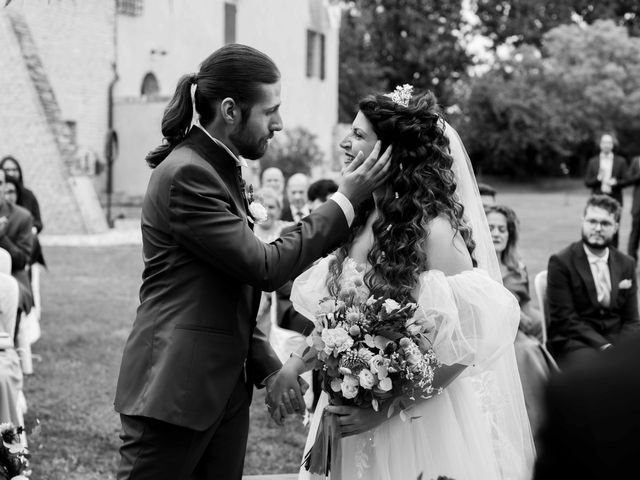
[{"left": 339, "top": 0, "right": 471, "bottom": 122}]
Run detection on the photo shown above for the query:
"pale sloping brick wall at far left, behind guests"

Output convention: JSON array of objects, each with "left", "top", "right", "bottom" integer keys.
[{"left": 0, "top": 6, "right": 108, "bottom": 234}]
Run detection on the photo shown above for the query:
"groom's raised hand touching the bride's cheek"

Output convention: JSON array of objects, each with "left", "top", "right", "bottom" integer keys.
[{"left": 338, "top": 140, "right": 391, "bottom": 206}]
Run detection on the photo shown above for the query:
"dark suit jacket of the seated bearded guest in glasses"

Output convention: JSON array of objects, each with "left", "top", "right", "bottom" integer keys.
[{"left": 547, "top": 241, "right": 640, "bottom": 362}]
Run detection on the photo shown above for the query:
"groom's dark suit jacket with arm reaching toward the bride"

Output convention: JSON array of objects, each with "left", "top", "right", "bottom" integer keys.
[{"left": 115, "top": 128, "right": 348, "bottom": 430}]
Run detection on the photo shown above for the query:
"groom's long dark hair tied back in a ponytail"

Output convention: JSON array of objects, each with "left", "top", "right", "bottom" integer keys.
[{"left": 146, "top": 43, "right": 280, "bottom": 168}]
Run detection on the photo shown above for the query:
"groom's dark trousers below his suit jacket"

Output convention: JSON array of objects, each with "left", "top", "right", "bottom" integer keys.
[{"left": 117, "top": 375, "right": 253, "bottom": 480}]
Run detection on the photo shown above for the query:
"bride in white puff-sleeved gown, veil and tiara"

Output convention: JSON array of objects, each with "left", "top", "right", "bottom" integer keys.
[{"left": 270, "top": 85, "right": 534, "bottom": 480}]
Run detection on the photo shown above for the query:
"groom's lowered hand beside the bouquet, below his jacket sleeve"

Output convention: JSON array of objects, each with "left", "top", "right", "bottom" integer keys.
[{"left": 265, "top": 368, "right": 309, "bottom": 425}]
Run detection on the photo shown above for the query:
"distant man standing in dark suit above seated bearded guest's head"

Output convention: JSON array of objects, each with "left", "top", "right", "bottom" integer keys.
[{"left": 584, "top": 133, "right": 627, "bottom": 248}]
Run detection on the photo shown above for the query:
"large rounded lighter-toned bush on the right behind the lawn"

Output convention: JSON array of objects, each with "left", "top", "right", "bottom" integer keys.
[{"left": 460, "top": 21, "right": 640, "bottom": 175}]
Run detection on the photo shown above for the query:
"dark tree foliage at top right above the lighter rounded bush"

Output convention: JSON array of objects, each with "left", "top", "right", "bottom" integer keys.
[{"left": 475, "top": 0, "right": 640, "bottom": 47}]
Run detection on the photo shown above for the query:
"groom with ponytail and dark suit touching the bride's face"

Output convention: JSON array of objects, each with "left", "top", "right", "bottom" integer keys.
[{"left": 115, "top": 45, "right": 389, "bottom": 480}]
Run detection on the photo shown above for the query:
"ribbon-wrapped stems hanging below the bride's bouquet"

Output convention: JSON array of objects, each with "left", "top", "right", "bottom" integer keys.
[{"left": 302, "top": 412, "right": 342, "bottom": 480}]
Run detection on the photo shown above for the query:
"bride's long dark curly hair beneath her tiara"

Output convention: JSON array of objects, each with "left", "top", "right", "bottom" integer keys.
[{"left": 327, "top": 92, "right": 476, "bottom": 301}]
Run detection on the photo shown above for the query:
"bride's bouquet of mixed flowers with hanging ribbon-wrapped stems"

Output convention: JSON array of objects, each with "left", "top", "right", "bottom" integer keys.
[{"left": 303, "top": 260, "right": 440, "bottom": 475}]
